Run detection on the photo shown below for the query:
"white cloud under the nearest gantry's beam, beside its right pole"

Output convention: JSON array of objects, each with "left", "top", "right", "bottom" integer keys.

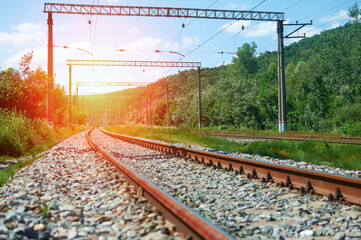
[{"left": 222, "top": 21, "right": 277, "bottom": 37}]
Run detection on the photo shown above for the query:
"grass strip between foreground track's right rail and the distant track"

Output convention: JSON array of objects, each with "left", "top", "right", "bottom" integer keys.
[{"left": 105, "top": 125, "right": 361, "bottom": 170}]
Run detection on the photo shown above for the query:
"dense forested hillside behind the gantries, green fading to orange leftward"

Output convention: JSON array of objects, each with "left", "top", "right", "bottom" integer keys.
[{"left": 83, "top": 21, "right": 361, "bottom": 135}]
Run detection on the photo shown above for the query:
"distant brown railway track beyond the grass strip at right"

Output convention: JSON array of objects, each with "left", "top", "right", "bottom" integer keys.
[{"left": 195, "top": 131, "right": 361, "bottom": 145}]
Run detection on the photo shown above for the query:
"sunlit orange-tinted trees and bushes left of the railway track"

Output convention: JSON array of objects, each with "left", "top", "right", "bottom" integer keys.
[{"left": 0, "top": 52, "right": 86, "bottom": 157}]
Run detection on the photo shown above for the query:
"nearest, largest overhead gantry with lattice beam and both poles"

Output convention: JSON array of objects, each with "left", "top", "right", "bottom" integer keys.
[{"left": 44, "top": 3, "right": 310, "bottom": 133}]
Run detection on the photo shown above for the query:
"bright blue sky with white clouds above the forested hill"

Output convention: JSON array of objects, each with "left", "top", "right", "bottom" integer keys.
[{"left": 0, "top": 0, "right": 361, "bottom": 94}]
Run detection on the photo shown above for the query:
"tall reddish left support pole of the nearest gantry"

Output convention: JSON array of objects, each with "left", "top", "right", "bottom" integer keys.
[{"left": 46, "top": 13, "right": 54, "bottom": 126}]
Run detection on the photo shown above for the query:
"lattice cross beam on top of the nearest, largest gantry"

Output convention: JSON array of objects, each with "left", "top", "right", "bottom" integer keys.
[{"left": 44, "top": 3, "right": 284, "bottom": 21}]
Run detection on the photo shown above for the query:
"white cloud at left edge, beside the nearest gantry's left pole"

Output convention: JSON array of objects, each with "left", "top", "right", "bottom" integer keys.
[{"left": 0, "top": 23, "right": 46, "bottom": 51}]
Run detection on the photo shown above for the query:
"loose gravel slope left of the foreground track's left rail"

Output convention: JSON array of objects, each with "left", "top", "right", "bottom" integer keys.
[{"left": 0, "top": 132, "right": 181, "bottom": 240}]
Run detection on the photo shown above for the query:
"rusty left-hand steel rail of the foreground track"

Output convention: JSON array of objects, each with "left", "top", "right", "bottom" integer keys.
[{"left": 86, "top": 129, "right": 234, "bottom": 240}]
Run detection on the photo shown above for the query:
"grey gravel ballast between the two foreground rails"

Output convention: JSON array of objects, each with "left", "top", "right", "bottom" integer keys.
[{"left": 91, "top": 130, "right": 361, "bottom": 240}]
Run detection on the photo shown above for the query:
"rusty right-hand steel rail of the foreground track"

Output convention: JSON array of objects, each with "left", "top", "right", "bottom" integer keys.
[{"left": 100, "top": 129, "right": 361, "bottom": 205}]
